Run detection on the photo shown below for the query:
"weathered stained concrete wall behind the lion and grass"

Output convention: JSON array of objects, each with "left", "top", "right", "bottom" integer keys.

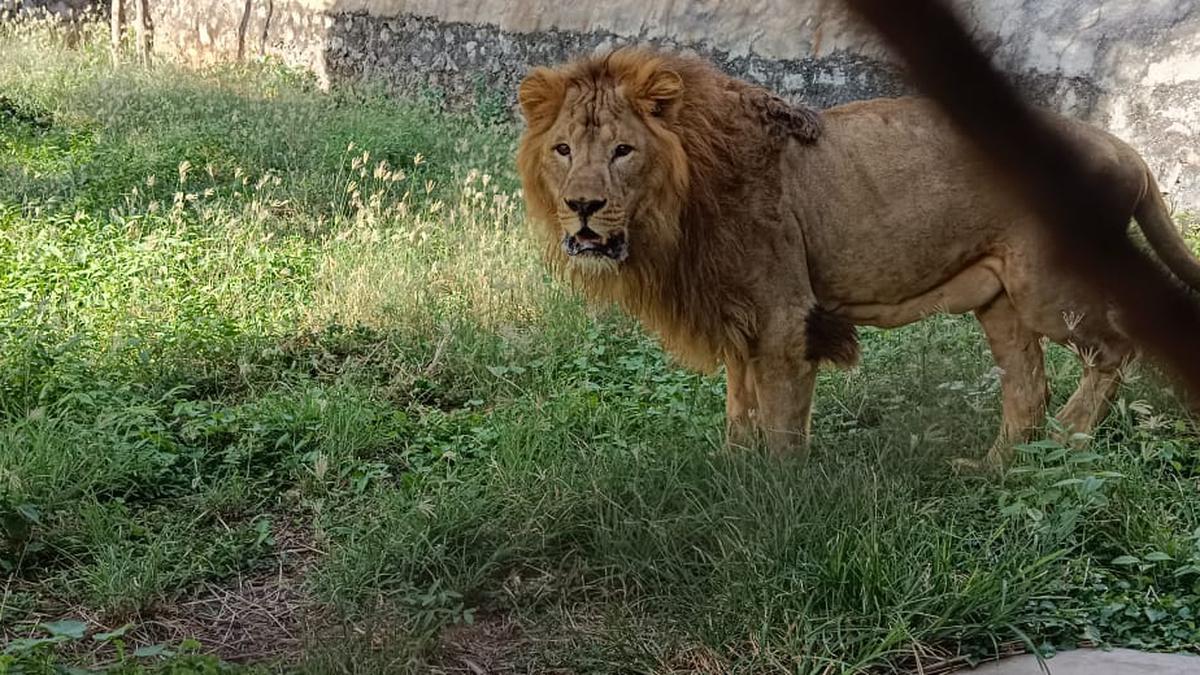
[{"left": 151, "top": 0, "right": 1200, "bottom": 208}]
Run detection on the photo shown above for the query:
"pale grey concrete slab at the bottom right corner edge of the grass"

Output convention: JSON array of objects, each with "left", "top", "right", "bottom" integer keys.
[{"left": 962, "top": 650, "right": 1200, "bottom": 675}]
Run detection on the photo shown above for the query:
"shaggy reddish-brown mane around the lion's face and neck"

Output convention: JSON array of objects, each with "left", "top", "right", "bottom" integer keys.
[{"left": 517, "top": 49, "right": 821, "bottom": 370}]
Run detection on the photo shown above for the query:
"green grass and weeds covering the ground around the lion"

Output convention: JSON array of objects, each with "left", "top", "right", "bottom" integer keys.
[{"left": 0, "top": 15, "right": 1200, "bottom": 673}]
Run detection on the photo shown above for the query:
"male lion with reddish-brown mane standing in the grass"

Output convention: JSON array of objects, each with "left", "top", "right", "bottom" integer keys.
[{"left": 517, "top": 49, "right": 1200, "bottom": 466}]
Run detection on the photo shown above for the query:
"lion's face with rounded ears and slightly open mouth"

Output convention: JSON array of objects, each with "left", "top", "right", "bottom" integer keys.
[{"left": 520, "top": 55, "right": 680, "bottom": 273}]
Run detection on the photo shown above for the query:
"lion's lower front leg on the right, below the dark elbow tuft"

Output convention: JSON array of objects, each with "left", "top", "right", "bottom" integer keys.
[{"left": 751, "top": 354, "right": 817, "bottom": 458}]
